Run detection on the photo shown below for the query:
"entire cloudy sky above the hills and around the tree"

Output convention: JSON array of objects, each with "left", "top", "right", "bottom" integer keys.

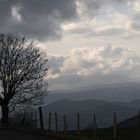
[{"left": 0, "top": 0, "right": 140, "bottom": 90}]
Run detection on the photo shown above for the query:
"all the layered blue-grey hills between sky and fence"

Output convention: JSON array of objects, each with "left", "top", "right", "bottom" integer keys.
[{"left": 40, "top": 83, "right": 140, "bottom": 129}]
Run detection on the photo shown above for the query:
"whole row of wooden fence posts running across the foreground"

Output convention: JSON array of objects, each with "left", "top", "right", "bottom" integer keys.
[{"left": 1, "top": 107, "right": 140, "bottom": 139}]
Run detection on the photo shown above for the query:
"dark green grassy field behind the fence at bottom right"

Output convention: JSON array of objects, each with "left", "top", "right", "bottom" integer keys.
[{"left": 66, "top": 128, "right": 140, "bottom": 140}]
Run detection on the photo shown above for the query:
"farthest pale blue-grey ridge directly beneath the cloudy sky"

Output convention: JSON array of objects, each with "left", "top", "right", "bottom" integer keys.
[{"left": 45, "top": 83, "right": 140, "bottom": 104}]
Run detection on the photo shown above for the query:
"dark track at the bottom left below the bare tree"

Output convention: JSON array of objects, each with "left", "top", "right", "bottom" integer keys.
[{"left": 0, "top": 129, "right": 58, "bottom": 140}]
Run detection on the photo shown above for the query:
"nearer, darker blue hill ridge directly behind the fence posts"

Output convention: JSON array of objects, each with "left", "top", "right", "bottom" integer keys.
[{"left": 43, "top": 99, "right": 140, "bottom": 129}]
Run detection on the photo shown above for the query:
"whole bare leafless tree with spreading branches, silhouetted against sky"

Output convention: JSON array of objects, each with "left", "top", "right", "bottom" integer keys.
[{"left": 0, "top": 34, "right": 48, "bottom": 125}]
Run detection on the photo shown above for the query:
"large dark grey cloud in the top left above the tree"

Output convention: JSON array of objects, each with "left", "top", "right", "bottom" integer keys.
[{"left": 0, "top": 0, "right": 77, "bottom": 40}]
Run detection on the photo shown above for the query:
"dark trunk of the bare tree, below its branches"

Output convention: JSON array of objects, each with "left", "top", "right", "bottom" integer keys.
[{"left": 1, "top": 104, "right": 9, "bottom": 127}]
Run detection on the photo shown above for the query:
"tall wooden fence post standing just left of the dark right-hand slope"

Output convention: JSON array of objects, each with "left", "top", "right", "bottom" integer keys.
[{"left": 113, "top": 112, "right": 117, "bottom": 140}]
